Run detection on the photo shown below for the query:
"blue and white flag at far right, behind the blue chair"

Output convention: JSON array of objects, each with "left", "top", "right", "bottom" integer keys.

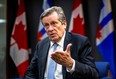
[{"left": 96, "top": 0, "right": 116, "bottom": 79}]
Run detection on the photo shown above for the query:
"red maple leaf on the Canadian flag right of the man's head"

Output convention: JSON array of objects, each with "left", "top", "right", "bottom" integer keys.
[{"left": 71, "top": 15, "right": 85, "bottom": 35}]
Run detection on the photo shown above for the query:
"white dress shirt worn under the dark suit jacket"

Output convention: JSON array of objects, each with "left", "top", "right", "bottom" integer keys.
[{"left": 44, "top": 33, "right": 75, "bottom": 79}]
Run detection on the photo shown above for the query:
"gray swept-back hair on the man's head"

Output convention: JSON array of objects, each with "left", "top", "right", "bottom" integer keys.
[{"left": 40, "top": 6, "right": 66, "bottom": 23}]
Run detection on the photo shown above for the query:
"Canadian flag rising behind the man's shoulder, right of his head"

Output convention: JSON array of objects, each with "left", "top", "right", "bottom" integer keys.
[{"left": 69, "top": 0, "right": 85, "bottom": 35}]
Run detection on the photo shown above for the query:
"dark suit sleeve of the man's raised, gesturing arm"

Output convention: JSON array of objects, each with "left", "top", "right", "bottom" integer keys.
[{"left": 72, "top": 39, "right": 98, "bottom": 79}]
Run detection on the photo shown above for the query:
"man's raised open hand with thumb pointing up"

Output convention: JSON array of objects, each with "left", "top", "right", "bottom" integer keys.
[{"left": 51, "top": 44, "right": 73, "bottom": 69}]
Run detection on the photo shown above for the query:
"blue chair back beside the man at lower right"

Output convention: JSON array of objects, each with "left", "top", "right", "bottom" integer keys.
[{"left": 95, "top": 62, "right": 113, "bottom": 79}]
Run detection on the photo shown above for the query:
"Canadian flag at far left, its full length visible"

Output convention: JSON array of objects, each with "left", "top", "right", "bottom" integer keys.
[{"left": 10, "top": 0, "right": 29, "bottom": 78}]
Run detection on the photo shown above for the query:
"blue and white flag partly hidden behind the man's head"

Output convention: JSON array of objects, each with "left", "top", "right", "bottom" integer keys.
[{"left": 38, "top": 0, "right": 52, "bottom": 41}]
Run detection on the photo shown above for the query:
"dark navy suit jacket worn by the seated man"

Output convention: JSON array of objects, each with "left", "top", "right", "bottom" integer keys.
[{"left": 25, "top": 32, "right": 98, "bottom": 79}]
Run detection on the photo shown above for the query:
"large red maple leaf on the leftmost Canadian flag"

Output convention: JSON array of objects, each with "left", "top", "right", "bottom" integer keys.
[{"left": 12, "top": 21, "right": 28, "bottom": 50}]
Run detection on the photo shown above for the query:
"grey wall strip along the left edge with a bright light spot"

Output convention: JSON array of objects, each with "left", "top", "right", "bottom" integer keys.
[{"left": 0, "top": 0, "right": 6, "bottom": 79}]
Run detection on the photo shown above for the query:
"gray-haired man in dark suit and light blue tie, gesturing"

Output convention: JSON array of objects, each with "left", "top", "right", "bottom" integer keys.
[{"left": 25, "top": 6, "right": 98, "bottom": 79}]
